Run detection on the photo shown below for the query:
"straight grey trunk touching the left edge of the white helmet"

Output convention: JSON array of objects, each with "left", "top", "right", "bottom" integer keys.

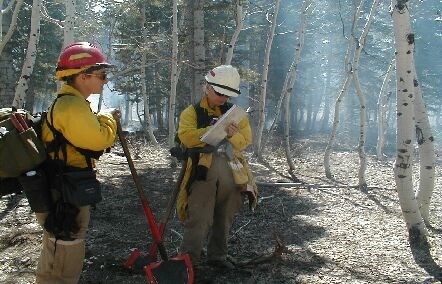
[{"left": 191, "top": 0, "right": 206, "bottom": 104}]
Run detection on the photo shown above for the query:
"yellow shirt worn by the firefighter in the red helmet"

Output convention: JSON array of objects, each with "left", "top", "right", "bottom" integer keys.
[{"left": 42, "top": 84, "right": 117, "bottom": 168}]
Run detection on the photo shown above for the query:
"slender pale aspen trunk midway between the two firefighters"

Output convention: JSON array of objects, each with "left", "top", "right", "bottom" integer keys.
[{"left": 141, "top": 6, "right": 158, "bottom": 145}]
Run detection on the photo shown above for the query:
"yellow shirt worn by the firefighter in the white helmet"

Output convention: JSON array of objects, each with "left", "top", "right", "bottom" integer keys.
[{"left": 177, "top": 96, "right": 252, "bottom": 221}]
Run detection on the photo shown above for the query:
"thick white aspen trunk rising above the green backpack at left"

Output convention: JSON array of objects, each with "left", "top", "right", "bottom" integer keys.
[{"left": 12, "top": 0, "right": 41, "bottom": 110}]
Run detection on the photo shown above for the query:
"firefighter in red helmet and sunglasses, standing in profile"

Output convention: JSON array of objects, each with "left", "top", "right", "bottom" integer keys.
[{"left": 36, "top": 42, "right": 120, "bottom": 284}]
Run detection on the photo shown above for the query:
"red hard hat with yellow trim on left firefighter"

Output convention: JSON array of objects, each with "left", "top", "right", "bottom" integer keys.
[{"left": 56, "top": 42, "right": 112, "bottom": 80}]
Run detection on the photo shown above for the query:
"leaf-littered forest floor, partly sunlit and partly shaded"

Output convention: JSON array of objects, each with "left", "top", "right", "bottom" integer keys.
[{"left": 0, "top": 135, "right": 442, "bottom": 284}]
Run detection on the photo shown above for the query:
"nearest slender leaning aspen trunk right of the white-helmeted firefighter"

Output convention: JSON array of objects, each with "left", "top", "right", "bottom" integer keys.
[{"left": 254, "top": 0, "right": 280, "bottom": 159}]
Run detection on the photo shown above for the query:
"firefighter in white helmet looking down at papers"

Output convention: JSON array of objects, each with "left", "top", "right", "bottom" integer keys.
[{"left": 177, "top": 65, "right": 258, "bottom": 268}]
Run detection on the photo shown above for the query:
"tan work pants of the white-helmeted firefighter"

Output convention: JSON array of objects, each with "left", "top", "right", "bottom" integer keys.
[{"left": 181, "top": 155, "right": 242, "bottom": 263}]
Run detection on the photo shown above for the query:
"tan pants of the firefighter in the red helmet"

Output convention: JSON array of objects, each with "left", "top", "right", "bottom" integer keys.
[{"left": 35, "top": 206, "right": 90, "bottom": 284}]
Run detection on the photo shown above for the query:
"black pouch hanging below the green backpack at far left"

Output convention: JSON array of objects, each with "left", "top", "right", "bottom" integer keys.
[{"left": 18, "top": 168, "right": 52, "bottom": 213}]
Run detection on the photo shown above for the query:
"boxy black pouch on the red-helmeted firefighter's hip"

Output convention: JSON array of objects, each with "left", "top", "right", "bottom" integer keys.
[{"left": 59, "top": 170, "right": 102, "bottom": 207}]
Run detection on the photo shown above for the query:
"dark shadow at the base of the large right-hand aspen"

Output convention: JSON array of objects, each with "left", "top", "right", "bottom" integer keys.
[{"left": 408, "top": 229, "right": 442, "bottom": 281}]
